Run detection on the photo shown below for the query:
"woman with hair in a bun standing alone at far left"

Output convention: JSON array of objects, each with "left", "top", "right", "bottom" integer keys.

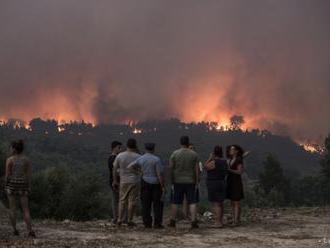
[{"left": 5, "top": 140, "right": 36, "bottom": 238}]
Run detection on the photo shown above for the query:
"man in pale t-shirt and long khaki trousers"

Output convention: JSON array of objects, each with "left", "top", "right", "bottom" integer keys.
[{"left": 113, "top": 139, "right": 140, "bottom": 227}]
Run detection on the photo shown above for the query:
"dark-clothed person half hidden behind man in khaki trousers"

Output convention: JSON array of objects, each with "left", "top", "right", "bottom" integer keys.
[{"left": 108, "top": 141, "right": 122, "bottom": 224}]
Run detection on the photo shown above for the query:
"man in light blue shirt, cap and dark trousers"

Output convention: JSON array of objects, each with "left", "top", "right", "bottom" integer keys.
[{"left": 128, "top": 143, "right": 165, "bottom": 228}]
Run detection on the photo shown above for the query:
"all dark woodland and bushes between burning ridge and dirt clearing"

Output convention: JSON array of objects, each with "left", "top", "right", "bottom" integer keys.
[{"left": 0, "top": 116, "right": 330, "bottom": 220}]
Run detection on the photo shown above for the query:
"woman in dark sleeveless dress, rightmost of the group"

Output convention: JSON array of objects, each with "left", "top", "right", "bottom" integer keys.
[{"left": 227, "top": 145, "right": 244, "bottom": 226}]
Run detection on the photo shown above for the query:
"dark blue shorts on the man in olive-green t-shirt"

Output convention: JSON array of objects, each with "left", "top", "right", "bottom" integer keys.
[{"left": 171, "top": 183, "right": 199, "bottom": 205}]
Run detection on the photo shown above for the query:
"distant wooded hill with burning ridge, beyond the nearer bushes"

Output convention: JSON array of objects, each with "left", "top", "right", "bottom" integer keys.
[{"left": 0, "top": 119, "right": 320, "bottom": 178}]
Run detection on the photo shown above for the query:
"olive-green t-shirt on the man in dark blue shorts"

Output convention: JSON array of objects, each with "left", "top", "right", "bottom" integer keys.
[{"left": 170, "top": 148, "right": 198, "bottom": 184}]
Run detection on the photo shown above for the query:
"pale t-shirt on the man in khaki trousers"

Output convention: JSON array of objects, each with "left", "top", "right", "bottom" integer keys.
[{"left": 113, "top": 151, "right": 141, "bottom": 184}]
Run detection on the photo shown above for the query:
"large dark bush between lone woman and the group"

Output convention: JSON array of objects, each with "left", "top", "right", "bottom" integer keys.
[{"left": 30, "top": 167, "right": 110, "bottom": 220}]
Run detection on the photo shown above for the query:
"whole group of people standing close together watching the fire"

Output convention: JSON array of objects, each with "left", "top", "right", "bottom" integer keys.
[{"left": 108, "top": 136, "right": 246, "bottom": 228}]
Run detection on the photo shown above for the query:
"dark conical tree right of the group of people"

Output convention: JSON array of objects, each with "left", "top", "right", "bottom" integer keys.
[{"left": 259, "top": 154, "right": 290, "bottom": 204}]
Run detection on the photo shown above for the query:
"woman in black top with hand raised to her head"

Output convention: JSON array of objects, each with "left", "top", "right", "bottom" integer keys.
[{"left": 205, "top": 146, "right": 227, "bottom": 228}]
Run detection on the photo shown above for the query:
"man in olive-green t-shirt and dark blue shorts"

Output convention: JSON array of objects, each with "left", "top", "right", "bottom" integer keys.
[{"left": 169, "top": 136, "right": 200, "bottom": 228}]
